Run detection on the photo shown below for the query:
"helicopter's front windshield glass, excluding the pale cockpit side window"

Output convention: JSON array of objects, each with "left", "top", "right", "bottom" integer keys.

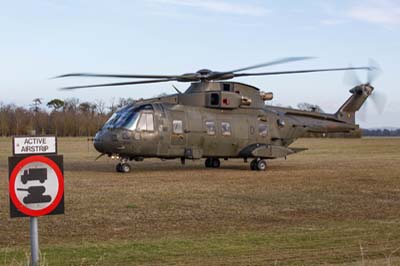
[{"left": 104, "top": 105, "right": 153, "bottom": 130}]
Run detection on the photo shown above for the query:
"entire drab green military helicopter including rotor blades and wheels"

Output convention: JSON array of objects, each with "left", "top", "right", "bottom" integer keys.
[{"left": 57, "top": 57, "right": 376, "bottom": 173}]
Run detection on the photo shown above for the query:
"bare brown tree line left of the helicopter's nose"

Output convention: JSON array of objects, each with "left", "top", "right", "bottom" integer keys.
[{"left": 0, "top": 98, "right": 134, "bottom": 137}]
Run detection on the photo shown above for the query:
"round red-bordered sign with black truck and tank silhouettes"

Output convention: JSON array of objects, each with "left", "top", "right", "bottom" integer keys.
[{"left": 9, "top": 156, "right": 64, "bottom": 216}]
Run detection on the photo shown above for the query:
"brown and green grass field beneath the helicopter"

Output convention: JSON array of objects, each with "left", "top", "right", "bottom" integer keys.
[{"left": 0, "top": 138, "right": 400, "bottom": 266}]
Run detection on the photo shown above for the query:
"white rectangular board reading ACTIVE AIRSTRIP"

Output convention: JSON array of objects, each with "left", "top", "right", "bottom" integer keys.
[{"left": 14, "top": 136, "right": 57, "bottom": 155}]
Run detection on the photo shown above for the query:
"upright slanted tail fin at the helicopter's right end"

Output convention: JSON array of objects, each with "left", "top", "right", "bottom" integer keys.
[{"left": 335, "top": 84, "right": 374, "bottom": 124}]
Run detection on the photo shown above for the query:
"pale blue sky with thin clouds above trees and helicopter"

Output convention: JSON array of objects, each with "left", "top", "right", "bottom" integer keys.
[{"left": 0, "top": 0, "right": 400, "bottom": 127}]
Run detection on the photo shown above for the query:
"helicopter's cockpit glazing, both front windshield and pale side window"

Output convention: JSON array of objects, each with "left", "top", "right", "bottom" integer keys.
[{"left": 103, "top": 104, "right": 154, "bottom": 131}]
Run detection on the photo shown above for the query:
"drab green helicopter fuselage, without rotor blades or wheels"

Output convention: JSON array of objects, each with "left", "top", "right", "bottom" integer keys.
[{"left": 94, "top": 82, "right": 368, "bottom": 160}]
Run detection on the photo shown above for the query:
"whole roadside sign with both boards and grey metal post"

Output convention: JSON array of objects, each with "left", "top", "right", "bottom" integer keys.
[{"left": 8, "top": 137, "right": 64, "bottom": 266}]
